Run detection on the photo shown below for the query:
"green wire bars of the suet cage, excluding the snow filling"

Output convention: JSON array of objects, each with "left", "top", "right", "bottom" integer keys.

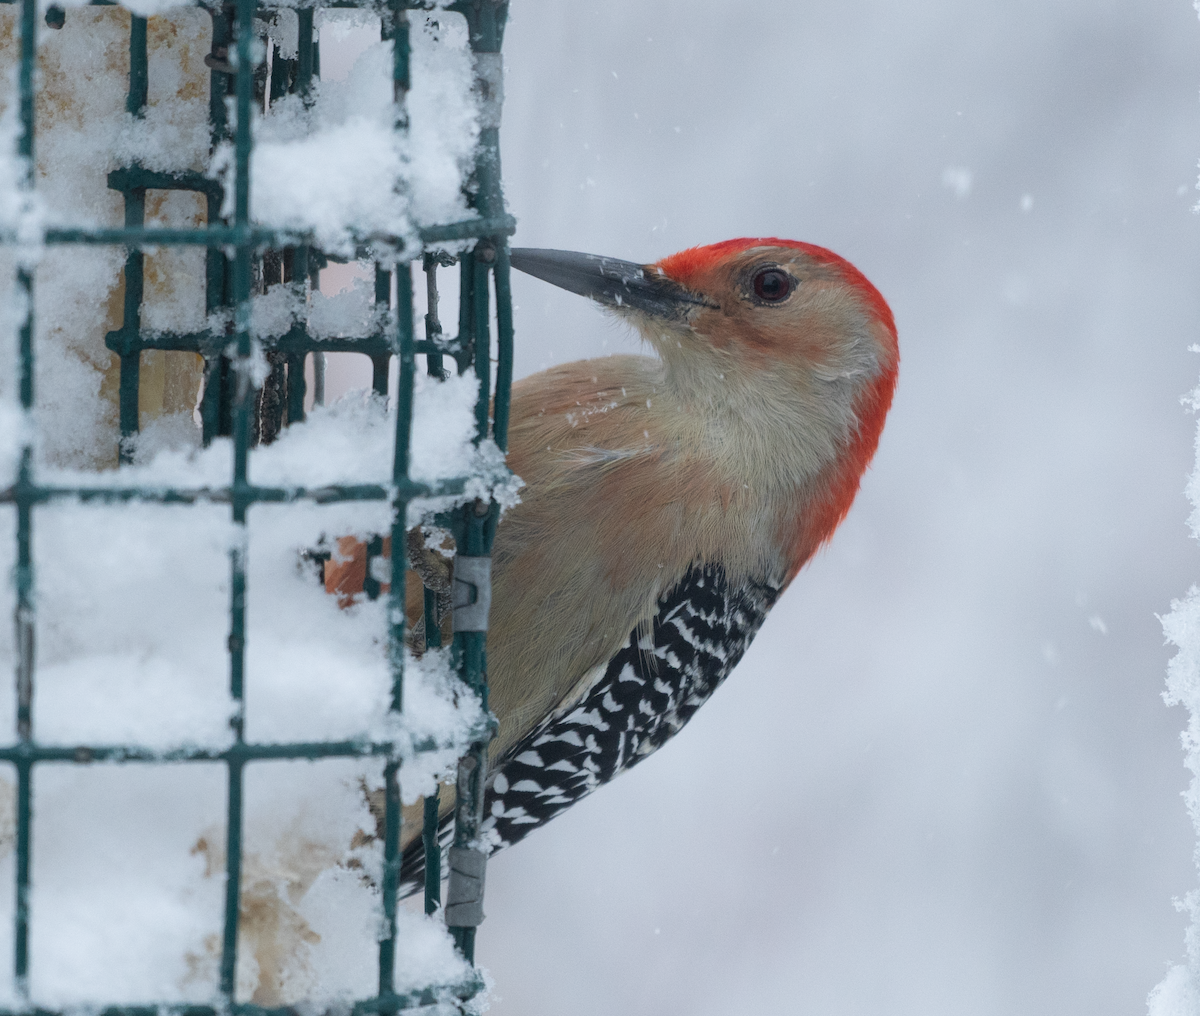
[{"left": 0, "top": 0, "right": 514, "bottom": 1016}]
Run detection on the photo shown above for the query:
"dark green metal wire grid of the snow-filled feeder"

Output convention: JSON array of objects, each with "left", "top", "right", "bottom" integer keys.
[{"left": 0, "top": 0, "right": 514, "bottom": 1016}]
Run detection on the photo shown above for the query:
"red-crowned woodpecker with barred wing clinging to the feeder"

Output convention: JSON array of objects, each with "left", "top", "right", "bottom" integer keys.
[{"left": 401, "top": 238, "right": 899, "bottom": 892}]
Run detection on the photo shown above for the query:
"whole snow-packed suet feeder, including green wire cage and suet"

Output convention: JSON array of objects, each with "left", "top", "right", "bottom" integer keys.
[{"left": 0, "top": 0, "right": 515, "bottom": 1016}]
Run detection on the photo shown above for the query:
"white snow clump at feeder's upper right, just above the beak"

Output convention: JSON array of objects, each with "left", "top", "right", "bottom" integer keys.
[{"left": 211, "top": 13, "right": 479, "bottom": 254}]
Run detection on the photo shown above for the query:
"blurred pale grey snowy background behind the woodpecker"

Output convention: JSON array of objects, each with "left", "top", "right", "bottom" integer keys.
[{"left": 460, "top": 0, "right": 1200, "bottom": 1016}]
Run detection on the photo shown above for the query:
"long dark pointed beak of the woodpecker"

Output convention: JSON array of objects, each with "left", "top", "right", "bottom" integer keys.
[{"left": 509, "top": 247, "right": 716, "bottom": 320}]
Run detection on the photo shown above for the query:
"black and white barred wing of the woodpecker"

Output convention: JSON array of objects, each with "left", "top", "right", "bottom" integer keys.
[{"left": 402, "top": 565, "right": 779, "bottom": 890}]
